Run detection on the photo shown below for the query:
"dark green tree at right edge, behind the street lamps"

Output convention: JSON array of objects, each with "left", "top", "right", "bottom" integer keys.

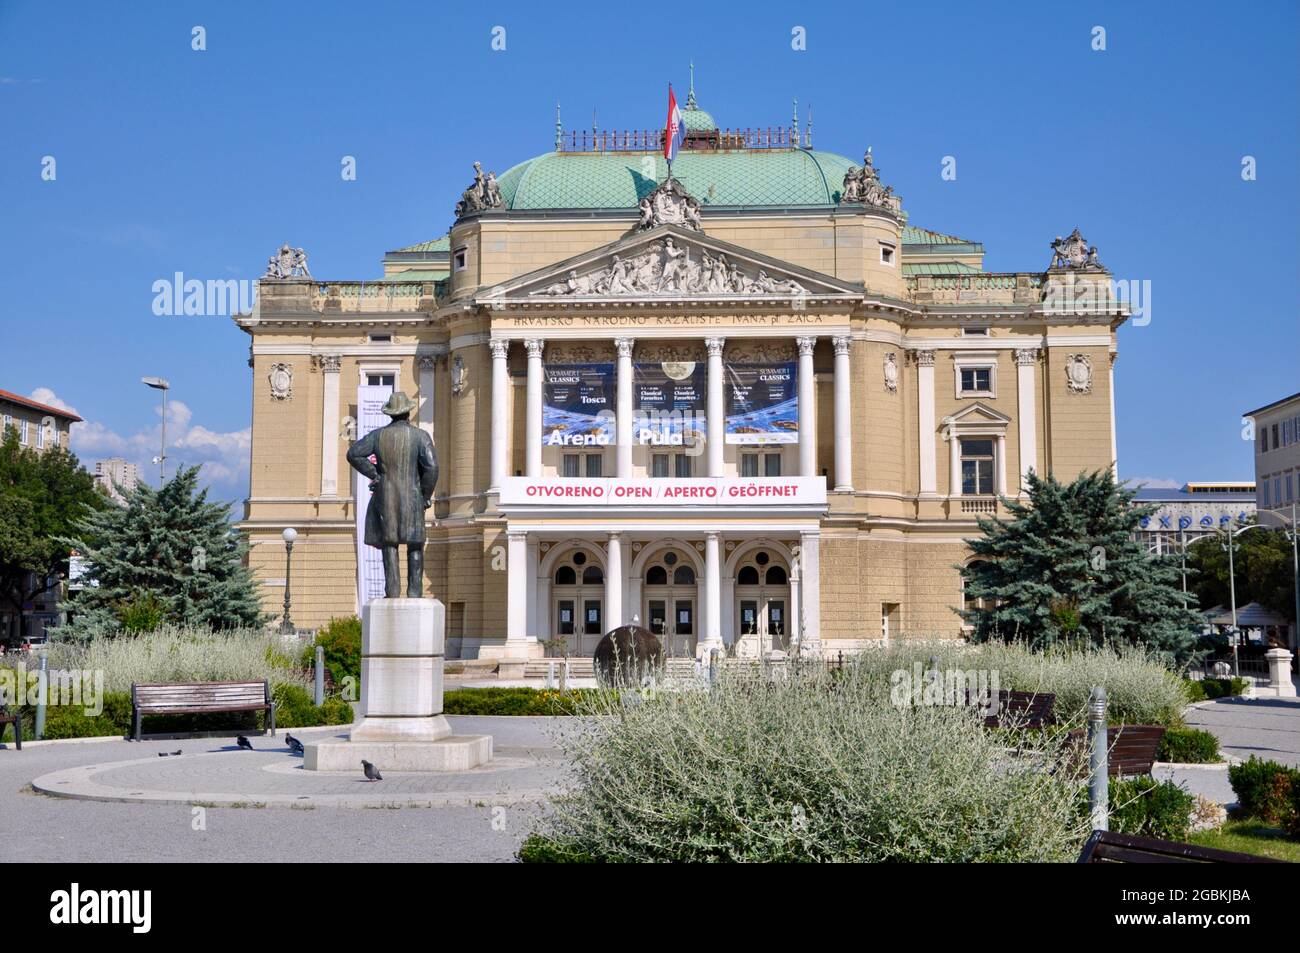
[{"left": 1187, "top": 529, "right": 1296, "bottom": 621}]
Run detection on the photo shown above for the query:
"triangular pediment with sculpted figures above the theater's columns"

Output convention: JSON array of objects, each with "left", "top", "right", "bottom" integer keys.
[{"left": 477, "top": 225, "right": 862, "bottom": 304}]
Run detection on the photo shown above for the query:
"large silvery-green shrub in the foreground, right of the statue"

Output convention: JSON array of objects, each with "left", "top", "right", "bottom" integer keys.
[{"left": 541, "top": 655, "right": 1088, "bottom": 862}]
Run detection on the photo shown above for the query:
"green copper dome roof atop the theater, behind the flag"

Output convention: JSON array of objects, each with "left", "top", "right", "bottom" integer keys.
[{"left": 498, "top": 146, "right": 853, "bottom": 209}]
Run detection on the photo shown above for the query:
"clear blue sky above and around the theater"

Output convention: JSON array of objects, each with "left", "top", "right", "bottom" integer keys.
[{"left": 0, "top": 0, "right": 1300, "bottom": 499}]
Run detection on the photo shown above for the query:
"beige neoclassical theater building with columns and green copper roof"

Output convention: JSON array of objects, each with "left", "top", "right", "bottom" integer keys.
[{"left": 237, "top": 94, "right": 1126, "bottom": 660}]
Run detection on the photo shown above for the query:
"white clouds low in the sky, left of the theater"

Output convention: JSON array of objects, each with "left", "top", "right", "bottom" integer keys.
[{"left": 31, "top": 387, "right": 252, "bottom": 499}]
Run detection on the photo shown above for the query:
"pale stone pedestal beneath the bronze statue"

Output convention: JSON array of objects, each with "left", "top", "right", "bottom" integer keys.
[{"left": 303, "top": 599, "right": 491, "bottom": 772}]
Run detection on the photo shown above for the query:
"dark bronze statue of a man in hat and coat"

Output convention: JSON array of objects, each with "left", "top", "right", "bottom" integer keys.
[{"left": 347, "top": 390, "right": 438, "bottom": 599}]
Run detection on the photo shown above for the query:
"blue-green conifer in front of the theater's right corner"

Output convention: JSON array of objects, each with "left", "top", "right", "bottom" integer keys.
[{"left": 958, "top": 469, "right": 1201, "bottom": 662}]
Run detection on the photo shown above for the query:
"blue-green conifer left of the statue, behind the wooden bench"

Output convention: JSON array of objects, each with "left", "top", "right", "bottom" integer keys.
[{"left": 64, "top": 467, "right": 269, "bottom": 637}]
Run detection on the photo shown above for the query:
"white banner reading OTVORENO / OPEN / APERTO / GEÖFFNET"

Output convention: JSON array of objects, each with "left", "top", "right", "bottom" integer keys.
[{"left": 501, "top": 476, "right": 826, "bottom": 508}]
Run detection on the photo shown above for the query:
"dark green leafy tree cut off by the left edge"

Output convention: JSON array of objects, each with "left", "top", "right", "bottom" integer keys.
[{"left": 0, "top": 426, "right": 107, "bottom": 641}]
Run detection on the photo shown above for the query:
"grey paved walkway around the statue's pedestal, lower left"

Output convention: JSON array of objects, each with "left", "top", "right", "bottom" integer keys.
[{"left": 0, "top": 716, "right": 571, "bottom": 862}]
